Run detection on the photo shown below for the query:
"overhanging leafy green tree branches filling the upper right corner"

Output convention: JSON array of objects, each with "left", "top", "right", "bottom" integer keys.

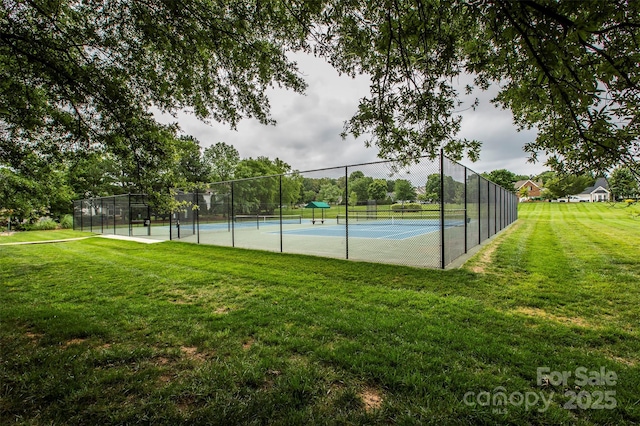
[{"left": 319, "top": 0, "right": 640, "bottom": 177}]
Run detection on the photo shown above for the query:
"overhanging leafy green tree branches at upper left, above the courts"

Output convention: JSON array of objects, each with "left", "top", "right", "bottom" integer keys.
[{"left": 0, "top": 0, "right": 306, "bottom": 209}]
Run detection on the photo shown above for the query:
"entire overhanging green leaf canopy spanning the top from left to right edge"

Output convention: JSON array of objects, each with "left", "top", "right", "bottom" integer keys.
[{"left": 0, "top": 0, "right": 640, "bottom": 216}]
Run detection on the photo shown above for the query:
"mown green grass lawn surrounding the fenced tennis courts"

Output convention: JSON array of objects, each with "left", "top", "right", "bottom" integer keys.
[{"left": 0, "top": 203, "right": 640, "bottom": 425}]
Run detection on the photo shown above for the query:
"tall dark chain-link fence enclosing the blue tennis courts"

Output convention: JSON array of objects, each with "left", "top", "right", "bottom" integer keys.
[{"left": 74, "top": 155, "right": 517, "bottom": 268}]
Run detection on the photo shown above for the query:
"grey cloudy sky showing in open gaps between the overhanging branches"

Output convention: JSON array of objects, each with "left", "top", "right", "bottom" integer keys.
[{"left": 154, "top": 55, "right": 545, "bottom": 174}]
